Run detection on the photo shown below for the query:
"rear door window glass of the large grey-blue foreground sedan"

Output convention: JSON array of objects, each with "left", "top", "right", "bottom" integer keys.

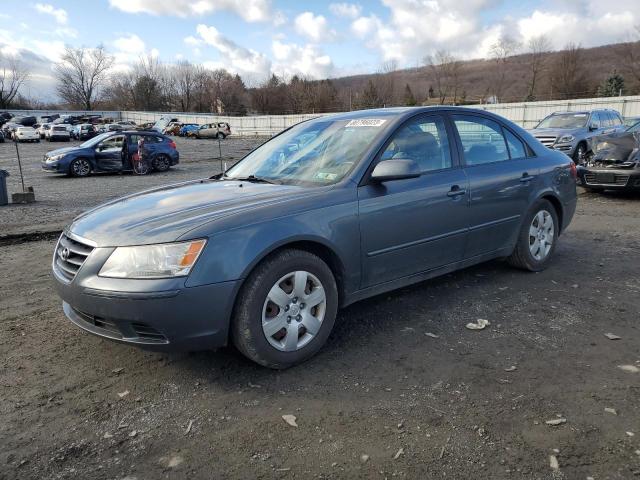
[{"left": 453, "top": 115, "right": 510, "bottom": 165}]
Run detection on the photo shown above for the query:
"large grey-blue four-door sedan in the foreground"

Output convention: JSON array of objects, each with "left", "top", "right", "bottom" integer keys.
[{"left": 53, "top": 107, "right": 576, "bottom": 368}]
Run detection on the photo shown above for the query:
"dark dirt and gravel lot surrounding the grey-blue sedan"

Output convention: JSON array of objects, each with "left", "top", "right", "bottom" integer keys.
[{"left": 0, "top": 137, "right": 640, "bottom": 480}]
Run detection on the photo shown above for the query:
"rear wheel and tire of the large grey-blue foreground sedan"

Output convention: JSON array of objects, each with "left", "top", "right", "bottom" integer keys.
[{"left": 508, "top": 199, "right": 560, "bottom": 272}]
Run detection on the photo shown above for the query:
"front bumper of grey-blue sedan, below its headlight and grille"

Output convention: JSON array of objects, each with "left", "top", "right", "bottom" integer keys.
[{"left": 53, "top": 238, "right": 239, "bottom": 351}]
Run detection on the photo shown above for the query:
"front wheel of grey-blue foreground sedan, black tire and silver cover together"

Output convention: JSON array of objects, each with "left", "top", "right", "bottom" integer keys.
[{"left": 231, "top": 249, "right": 338, "bottom": 369}]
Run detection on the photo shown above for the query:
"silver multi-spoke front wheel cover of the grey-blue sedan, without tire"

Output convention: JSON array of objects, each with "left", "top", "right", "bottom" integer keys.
[{"left": 262, "top": 271, "right": 327, "bottom": 352}]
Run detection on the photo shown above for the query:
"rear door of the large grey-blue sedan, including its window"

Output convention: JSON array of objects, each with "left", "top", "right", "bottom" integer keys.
[{"left": 452, "top": 114, "right": 539, "bottom": 258}]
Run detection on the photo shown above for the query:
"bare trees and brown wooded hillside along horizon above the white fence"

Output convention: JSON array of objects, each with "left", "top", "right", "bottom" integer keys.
[{"left": 0, "top": 30, "right": 640, "bottom": 115}]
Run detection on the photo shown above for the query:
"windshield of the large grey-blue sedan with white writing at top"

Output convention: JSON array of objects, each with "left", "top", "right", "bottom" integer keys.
[{"left": 226, "top": 118, "right": 387, "bottom": 185}]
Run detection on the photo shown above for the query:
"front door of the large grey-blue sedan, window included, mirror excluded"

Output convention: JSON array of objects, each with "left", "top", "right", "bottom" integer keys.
[{"left": 358, "top": 115, "right": 469, "bottom": 288}]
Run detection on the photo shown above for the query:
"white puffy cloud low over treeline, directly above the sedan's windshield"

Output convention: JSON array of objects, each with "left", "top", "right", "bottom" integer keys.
[{"left": 271, "top": 40, "right": 334, "bottom": 79}]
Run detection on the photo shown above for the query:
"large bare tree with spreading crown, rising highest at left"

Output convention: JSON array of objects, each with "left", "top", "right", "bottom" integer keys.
[{"left": 55, "top": 45, "right": 113, "bottom": 110}]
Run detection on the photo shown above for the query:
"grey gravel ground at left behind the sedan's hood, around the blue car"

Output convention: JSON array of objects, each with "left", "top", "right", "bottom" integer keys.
[{"left": 0, "top": 137, "right": 265, "bottom": 236}]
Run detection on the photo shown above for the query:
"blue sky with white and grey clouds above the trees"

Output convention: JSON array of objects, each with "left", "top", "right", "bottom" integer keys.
[{"left": 0, "top": 0, "right": 640, "bottom": 100}]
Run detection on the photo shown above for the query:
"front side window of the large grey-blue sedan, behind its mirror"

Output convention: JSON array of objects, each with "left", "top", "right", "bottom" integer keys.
[{"left": 381, "top": 116, "right": 451, "bottom": 172}]
